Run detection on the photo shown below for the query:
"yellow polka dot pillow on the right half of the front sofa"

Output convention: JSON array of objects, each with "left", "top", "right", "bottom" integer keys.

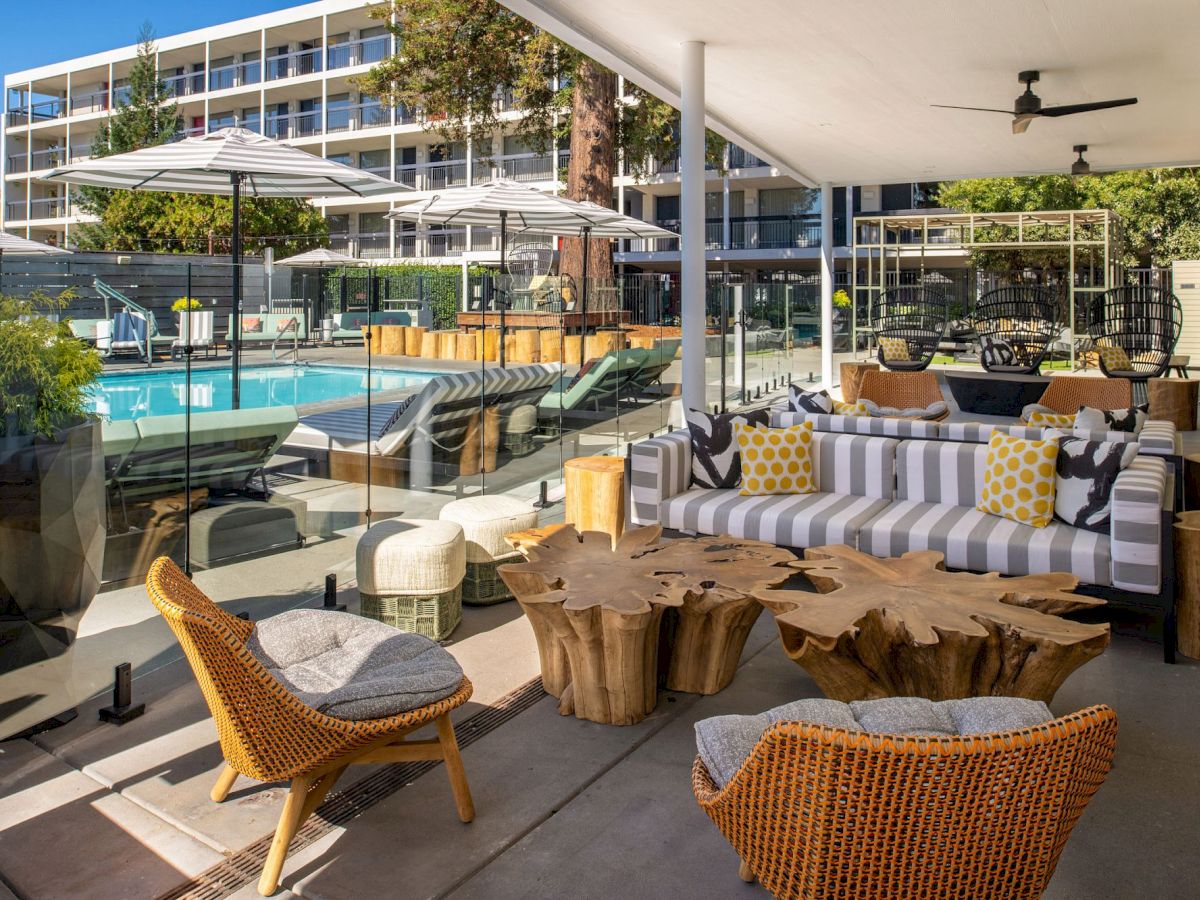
[{"left": 976, "top": 434, "right": 1058, "bottom": 528}]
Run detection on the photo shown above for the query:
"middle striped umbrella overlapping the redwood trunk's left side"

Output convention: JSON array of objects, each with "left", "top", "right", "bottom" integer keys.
[{"left": 388, "top": 179, "right": 657, "bottom": 366}]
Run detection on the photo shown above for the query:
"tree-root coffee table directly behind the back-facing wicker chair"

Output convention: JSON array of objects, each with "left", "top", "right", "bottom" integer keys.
[{"left": 755, "top": 545, "right": 1109, "bottom": 701}]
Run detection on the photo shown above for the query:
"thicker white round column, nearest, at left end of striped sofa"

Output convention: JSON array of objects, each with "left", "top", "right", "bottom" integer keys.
[{"left": 679, "top": 41, "right": 707, "bottom": 409}]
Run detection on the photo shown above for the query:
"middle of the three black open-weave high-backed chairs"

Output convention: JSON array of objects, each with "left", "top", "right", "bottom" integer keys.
[{"left": 972, "top": 284, "right": 1062, "bottom": 374}]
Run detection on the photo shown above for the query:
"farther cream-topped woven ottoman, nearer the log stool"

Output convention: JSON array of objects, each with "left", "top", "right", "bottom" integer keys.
[{"left": 439, "top": 494, "right": 538, "bottom": 606}]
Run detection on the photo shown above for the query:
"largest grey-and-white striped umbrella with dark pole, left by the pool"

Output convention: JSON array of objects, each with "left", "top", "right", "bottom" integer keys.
[{"left": 46, "top": 128, "right": 412, "bottom": 409}]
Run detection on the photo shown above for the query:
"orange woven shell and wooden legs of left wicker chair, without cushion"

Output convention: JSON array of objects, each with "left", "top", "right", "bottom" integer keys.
[{"left": 146, "top": 557, "right": 475, "bottom": 896}]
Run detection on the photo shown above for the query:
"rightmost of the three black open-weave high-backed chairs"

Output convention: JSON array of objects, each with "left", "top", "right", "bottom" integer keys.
[{"left": 1087, "top": 284, "right": 1183, "bottom": 390}]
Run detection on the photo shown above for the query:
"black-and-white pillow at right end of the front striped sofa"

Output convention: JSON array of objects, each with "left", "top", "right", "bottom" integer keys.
[{"left": 1054, "top": 437, "right": 1139, "bottom": 534}]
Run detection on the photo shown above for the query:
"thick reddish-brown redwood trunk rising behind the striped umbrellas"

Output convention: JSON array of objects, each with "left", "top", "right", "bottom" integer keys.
[{"left": 559, "top": 60, "right": 617, "bottom": 287}]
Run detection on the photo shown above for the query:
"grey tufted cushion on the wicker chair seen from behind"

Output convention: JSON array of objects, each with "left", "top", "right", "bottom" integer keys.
[{"left": 696, "top": 697, "right": 1054, "bottom": 787}]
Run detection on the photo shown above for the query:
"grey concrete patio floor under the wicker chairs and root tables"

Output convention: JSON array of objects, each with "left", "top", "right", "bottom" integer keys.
[{"left": 0, "top": 355, "right": 1200, "bottom": 900}]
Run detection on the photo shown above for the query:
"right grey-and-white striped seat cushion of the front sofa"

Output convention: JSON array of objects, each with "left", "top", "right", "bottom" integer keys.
[{"left": 858, "top": 500, "right": 1112, "bottom": 584}]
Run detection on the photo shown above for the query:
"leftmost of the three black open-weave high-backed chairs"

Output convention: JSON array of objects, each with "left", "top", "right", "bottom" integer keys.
[{"left": 871, "top": 284, "right": 950, "bottom": 372}]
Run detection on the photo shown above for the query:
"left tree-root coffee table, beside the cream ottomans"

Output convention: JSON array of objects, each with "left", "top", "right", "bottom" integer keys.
[{"left": 499, "top": 526, "right": 796, "bottom": 725}]
